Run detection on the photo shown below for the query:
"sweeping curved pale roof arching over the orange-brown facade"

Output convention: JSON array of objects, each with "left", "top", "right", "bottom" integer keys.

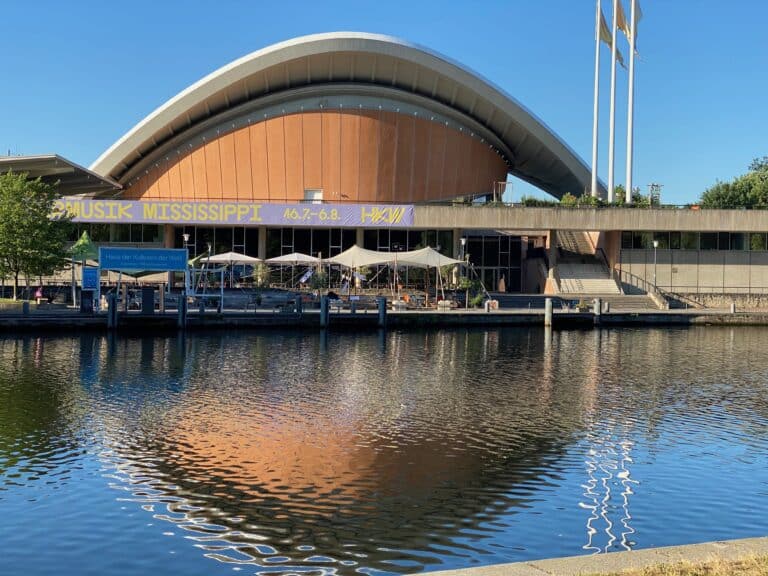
[{"left": 91, "top": 32, "right": 590, "bottom": 197}]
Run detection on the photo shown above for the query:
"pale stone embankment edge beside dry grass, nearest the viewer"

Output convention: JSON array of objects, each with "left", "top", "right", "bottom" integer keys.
[{"left": 420, "top": 537, "right": 768, "bottom": 576}]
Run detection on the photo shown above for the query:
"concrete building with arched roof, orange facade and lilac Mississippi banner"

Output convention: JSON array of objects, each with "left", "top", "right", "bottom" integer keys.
[{"left": 0, "top": 32, "right": 768, "bottom": 304}]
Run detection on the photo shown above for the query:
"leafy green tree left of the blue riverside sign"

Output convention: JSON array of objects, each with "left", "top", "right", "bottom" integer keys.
[{"left": 0, "top": 171, "right": 71, "bottom": 300}]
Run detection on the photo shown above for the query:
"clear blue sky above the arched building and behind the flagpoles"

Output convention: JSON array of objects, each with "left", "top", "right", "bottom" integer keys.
[{"left": 0, "top": 0, "right": 768, "bottom": 203}]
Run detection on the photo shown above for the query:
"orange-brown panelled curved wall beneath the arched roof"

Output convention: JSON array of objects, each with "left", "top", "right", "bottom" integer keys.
[{"left": 123, "top": 110, "right": 507, "bottom": 203}]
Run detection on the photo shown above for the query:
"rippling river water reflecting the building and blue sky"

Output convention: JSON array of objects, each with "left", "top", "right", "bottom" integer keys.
[{"left": 0, "top": 328, "right": 768, "bottom": 575}]
